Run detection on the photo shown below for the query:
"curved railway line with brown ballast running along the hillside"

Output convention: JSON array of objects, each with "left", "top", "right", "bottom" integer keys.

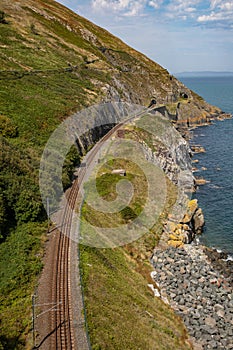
[{"left": 40, "top": 108, "right": 155, "bottom": 350}]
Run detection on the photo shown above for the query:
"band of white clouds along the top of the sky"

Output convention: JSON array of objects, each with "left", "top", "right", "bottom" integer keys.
[{"left": 89, "top": 0, "right": 233, "bottom": 29}]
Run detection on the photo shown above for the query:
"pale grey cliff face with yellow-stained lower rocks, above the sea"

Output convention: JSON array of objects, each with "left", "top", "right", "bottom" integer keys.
[{"left": 134, "top": 120, "right": 205, "bottom": 248}]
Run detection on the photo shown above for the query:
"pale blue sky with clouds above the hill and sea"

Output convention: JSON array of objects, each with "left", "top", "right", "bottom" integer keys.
[{"left": 59, "top": 0, "right": 233, "bottom": 73}]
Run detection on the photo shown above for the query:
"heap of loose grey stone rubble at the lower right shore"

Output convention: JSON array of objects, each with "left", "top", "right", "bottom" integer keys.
[{"left": 151, "top": 245, "right": 233, "bottom": 350}]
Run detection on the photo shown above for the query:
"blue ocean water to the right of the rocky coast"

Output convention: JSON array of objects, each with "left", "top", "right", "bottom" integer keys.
[{"left": 180, "top": 77, "right": 233, "bottom": 256}]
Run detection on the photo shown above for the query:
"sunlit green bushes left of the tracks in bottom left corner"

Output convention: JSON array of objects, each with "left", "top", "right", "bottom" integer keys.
[{"left": 0, "top": 223, "right": 46, "bottom": 349}]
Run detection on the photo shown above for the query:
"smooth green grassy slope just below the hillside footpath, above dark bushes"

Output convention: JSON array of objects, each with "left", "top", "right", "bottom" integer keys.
[{"left": 0, "top": 73, "right": 98, "bottom": 147}]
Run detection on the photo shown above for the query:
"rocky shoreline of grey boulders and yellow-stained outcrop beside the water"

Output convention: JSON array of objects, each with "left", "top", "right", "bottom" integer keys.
[{"left": 149, "top": 115, "right": 233, "bottom": 350}]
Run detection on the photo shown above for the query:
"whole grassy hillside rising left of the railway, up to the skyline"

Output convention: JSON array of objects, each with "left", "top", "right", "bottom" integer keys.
[{"left": 0, "top": 0, "right": 213, "bottom": 349}]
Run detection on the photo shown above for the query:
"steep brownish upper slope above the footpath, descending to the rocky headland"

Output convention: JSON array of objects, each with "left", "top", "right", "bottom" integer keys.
[{"left": 0, "top": 0, "right": 228, "bottom": 125}]
